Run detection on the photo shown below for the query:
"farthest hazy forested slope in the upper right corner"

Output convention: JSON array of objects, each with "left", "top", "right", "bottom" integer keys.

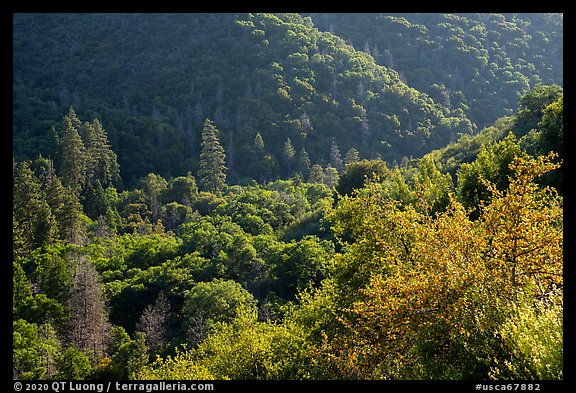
[{"left": 311, "top": 13, "right": 563, "bottom": 129}]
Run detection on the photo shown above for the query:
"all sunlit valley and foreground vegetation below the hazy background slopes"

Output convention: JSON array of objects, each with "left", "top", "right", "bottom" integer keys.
[{"left": 12, "top": 85, "right": 563, "bottom": 380}]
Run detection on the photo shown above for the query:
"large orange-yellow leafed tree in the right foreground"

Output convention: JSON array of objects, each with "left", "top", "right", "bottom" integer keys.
[{"left": 324, "top": 155, "right": 563, "bottom": 379}]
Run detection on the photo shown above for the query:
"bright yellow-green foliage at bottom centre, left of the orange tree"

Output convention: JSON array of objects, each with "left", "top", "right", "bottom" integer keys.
[{"left": 138, "top": 306, "right": 305, "bottom": 380}]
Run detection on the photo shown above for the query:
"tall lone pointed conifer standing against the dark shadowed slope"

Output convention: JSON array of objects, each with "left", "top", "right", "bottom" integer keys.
[{"left": 198, "top": 119, "right": 226, "bottom": 194}]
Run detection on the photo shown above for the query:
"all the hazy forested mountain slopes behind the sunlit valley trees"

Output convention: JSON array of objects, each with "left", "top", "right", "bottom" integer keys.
[{"left": 13, "top": 14, "right": 563, "bottom": 184}]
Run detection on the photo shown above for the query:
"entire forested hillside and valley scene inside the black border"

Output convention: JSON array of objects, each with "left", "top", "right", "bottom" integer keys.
[{"left": 12, "top": 13, "right": 564, "bottom": 381}]
